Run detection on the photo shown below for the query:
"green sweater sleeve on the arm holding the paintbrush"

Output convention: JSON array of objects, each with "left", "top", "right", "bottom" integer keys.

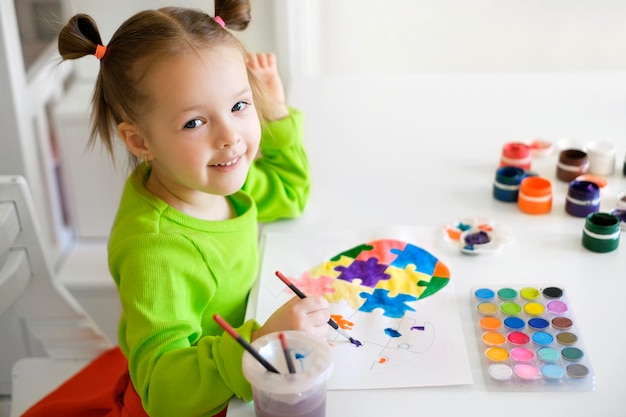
[{"left": 110, "top": 234, "right": 259, "bottom": 417}]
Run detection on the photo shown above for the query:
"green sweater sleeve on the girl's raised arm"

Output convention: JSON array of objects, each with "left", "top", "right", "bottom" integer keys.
[{"left": 243, "top": 108, "right": 311, "bottom": 222}]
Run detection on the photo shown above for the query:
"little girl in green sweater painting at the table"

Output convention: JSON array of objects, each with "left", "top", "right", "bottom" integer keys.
[{"left": 51, "top": 0, "right": 329, "bottom": 417}]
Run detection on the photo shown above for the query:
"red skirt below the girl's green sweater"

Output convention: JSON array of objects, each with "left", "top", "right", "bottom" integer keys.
[{"left": 22, "top": 347, "right": 226, "bottom": 417}]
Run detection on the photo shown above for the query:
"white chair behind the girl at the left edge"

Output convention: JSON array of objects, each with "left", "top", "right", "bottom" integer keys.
[{"left": 0, "top": 175, "right": 113, "bottom": 417}]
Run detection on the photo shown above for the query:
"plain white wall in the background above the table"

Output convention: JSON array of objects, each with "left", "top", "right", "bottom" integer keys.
[{"left": 286, "top": 0, "right": 626, "bottom": 74}]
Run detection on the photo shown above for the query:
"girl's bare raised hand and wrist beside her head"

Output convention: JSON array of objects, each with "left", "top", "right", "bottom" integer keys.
[{"left": 246, "top": 53, "right": 289, "bottom": 120}]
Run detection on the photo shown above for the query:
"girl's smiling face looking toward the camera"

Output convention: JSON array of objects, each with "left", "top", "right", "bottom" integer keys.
[{"left": 129, "top": 46, "right": 261, "bottom": 211}]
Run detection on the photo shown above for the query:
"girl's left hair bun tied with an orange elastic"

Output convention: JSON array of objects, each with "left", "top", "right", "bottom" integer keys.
[{"left": 58, "top": 14, "right": 102, "bottom": 59}]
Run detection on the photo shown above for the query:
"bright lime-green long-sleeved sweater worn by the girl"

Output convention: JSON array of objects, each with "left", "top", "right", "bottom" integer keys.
[{"left": 108, "top": 109, "right": 310, "bottom": 417}]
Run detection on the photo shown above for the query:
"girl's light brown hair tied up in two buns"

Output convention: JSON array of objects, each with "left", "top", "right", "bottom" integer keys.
[{"left": 58, "top": 0, "right": 267, "bottom": 167}]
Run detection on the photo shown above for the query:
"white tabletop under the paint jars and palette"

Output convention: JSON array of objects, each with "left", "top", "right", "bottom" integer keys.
[{"left": 229, "top": 74, "right": 626, "bottom": 417}]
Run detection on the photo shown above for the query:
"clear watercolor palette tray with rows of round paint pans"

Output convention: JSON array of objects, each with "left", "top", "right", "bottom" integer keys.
[{"left": 470, "top": 285, "right": 595, "bottom": 391}]
